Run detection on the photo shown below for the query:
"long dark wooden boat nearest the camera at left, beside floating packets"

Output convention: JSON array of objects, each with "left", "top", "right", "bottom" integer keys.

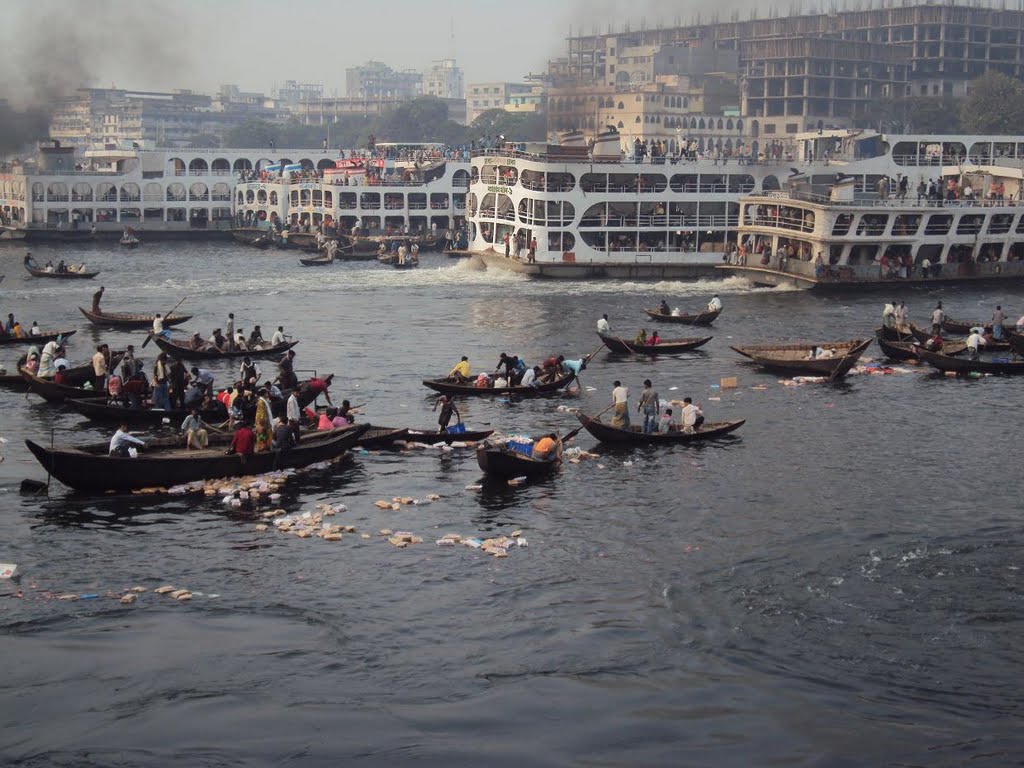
[{"left": 25, "top": 424, "right": 370, "bottom": 494}]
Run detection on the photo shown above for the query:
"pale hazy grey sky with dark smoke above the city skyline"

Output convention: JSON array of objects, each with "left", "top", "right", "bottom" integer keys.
[{"left": 0, "top": 0, "right": 770, "bottom": 96}]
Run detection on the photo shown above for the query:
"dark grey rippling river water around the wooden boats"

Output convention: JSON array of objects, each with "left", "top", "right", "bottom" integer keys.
[{"left": 0, "top": 244, "right": 1024, "bottom": 766}]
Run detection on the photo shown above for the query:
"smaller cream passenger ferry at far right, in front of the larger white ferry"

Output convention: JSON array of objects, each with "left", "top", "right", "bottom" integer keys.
[{"left": 720, "top": 164, "right": 1024, "bottom": 291}]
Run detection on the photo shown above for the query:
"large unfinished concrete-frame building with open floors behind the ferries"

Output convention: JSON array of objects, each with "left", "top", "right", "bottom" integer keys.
[{"left": 551, "top": 2, "right": 1024, "bottom": 140}]
